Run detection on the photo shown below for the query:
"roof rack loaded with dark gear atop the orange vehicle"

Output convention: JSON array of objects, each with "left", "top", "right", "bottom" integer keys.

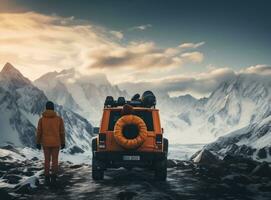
[{"left": 104, "top": 91, "right": 156, "bottom": 108}]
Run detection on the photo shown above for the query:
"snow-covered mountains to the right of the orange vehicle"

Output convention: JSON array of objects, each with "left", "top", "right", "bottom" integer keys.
[{"left": 158, "top": 74, "right": 271, "bottom": 143}]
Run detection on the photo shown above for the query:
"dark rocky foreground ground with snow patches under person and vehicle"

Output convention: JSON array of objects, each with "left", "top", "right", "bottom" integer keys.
[{"left": 0, "top": 145, "right": 271, "bottom": 200}]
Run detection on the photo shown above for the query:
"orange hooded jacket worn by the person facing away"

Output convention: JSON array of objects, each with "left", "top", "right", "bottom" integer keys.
[{"left": 36, "top": 110, "right": 65, "bottom": 147}]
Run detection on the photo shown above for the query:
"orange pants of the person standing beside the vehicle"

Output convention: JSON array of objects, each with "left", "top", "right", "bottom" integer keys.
[{"left": 43, "top": 147, "right": 59, "bottom": 176}]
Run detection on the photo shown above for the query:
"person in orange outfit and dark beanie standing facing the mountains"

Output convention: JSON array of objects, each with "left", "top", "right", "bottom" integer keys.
[{"left": 36, "top": 101, "right": 65, "bottom": 184}]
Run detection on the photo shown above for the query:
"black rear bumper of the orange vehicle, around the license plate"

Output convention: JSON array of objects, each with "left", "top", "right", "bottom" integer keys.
[{"left": 94, "top": 151, "right": 167, "bottom": 168}]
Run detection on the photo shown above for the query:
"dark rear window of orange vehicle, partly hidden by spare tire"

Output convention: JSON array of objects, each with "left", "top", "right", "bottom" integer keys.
[{"left": 108, "top": 110, "right": 153, "bottom": 131}]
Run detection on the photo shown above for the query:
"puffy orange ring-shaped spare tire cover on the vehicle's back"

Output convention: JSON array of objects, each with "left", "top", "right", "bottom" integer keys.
[{"left": 114, "top": 115, "right": 147, "bottom": 149}]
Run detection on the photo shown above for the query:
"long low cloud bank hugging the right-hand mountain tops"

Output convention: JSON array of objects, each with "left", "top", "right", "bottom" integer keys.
[{"left": 120, "top": 65, "right": 271, "bottom": 97}]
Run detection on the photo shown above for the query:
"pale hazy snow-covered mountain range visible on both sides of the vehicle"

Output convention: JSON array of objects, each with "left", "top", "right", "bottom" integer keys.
[{"left": 34, "top": 66, "right": 271, "bottom": 143}]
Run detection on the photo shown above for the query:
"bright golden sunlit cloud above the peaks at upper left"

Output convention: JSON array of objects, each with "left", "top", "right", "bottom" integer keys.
[{"left": 0, "top": 12, "right": 108, "bottom": 79}]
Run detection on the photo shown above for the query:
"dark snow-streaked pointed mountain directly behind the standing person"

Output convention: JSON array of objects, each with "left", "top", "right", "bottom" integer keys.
[{"left": 0, "top": 63, "right": 92, "bottom": 150}]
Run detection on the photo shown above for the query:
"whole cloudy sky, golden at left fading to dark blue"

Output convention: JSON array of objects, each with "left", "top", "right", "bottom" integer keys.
[{"left": 0, "top": 0, "right": 271, "bottom": 97}]
